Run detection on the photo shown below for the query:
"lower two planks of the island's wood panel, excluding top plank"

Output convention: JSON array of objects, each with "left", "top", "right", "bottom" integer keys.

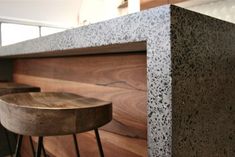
[{"left": 14, "top": 74, "right": 147, "bottom": 157}]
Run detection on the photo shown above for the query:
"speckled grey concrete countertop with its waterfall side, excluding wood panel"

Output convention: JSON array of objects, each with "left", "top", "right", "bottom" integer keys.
[{"left": 0, "top": 5, "right": 235, "bottom": 157}]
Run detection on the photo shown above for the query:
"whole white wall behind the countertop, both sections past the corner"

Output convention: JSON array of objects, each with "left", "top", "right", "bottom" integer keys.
[{"left": 0, "top": 0, "right": 127, "bottom": 27}]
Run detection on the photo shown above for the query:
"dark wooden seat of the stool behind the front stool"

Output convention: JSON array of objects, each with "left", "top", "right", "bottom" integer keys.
[{"left": 0, "top": 82, "right": 40, "bottom": 96}]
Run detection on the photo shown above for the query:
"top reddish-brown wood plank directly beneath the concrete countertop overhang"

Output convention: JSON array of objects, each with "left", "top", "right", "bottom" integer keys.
[{"left": 14, "top": 53, "right": 147, "bottom": 91}]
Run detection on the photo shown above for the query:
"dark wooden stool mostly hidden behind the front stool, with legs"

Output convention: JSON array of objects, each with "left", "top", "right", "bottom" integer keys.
[{"left": 0, "top": 82, "right": 40, "bottom": 154}]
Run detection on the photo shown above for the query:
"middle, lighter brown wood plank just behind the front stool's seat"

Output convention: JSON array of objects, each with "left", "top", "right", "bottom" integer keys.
[{"left": 13, "top": 74, "right": 147, "bottom": 139}]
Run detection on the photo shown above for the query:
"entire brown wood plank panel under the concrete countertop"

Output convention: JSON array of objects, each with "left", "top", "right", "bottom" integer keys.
[{"left": 13, "top": 53, "right": 147, "bottom": 157}]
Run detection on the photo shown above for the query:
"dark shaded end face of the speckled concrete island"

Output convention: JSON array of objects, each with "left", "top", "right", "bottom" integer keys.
[{"left": 171, "top": 8, "right": 235, "bottom": 157}]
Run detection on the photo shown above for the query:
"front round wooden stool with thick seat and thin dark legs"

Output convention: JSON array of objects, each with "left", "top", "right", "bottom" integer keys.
[{"left": 0, "top": 92, "right": 112, "bottom": 157}]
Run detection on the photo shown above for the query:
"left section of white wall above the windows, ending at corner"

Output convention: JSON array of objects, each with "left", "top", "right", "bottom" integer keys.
[{"left": 0, "top": 0, "right": 80, "bottom": 27}]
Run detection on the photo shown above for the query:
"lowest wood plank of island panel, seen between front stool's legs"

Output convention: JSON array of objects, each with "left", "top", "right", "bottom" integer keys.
[{"left": 29, "top": 131, "right": 147, "bottom": 157}]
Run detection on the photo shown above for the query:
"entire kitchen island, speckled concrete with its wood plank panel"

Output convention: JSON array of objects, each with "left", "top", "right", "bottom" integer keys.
[{"left": 0, "top": 5, "right": 235, "bottom": 157}]
